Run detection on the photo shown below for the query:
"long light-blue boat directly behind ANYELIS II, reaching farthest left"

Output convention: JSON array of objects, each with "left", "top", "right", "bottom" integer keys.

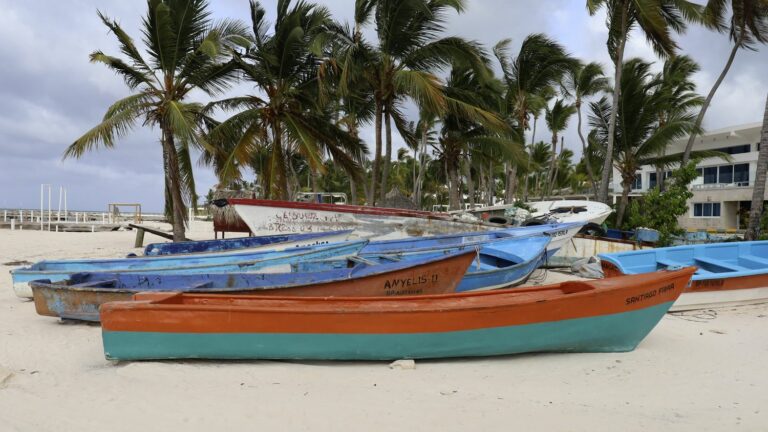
[{"left": 11, "top": 240, "right": 368, "bottom": 298}]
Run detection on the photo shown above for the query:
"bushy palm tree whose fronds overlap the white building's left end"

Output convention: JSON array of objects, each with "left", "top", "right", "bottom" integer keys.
[{"left": 589, "top": 59, "right": 721, "bottom": 227}]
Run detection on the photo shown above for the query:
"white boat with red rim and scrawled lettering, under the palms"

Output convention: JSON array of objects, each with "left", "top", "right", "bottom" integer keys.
[{"left": 226, "top": 198, "right": 502, "bottom": 239}]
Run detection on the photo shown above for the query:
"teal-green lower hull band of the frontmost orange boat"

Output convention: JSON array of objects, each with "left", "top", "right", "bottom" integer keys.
[{"left": 103, "top": 302, "right": 672, "bottom": 360}]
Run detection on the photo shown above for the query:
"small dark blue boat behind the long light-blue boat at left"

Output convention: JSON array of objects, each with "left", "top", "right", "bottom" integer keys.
[{"left": 144, "top": 230, "right": 352, "bottom": 256}]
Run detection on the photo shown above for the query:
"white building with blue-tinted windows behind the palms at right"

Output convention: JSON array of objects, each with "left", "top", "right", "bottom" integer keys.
[{"left": 612, "top": 123, "right": 768, "bottom": 229}]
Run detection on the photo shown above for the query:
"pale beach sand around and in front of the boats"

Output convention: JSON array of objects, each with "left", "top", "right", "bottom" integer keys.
[{"left": 0, "top": 230, "right": 768, "bottom": 432}]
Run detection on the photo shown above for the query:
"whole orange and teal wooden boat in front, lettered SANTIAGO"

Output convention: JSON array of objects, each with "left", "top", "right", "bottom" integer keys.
[{"left": 101, "top": 268, "right": 694, "bottom": 360}]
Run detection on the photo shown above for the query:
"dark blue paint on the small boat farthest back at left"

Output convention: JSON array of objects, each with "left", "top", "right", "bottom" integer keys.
[{"left": 144, "top": 230, "right": 352, "bottom": 256}]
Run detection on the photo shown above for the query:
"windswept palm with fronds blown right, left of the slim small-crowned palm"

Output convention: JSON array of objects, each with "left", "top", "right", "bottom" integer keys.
[{"left": 493, "top": 34, "right": 574, "bottom": 203}]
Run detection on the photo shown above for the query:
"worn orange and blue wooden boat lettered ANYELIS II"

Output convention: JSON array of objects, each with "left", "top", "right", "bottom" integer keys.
[{"left": 30, "top": 250, "right": 475, "bottom": 321}]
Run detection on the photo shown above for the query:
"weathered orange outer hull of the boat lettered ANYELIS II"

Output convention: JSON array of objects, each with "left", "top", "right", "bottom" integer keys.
[{"left": 31, "top": 253, "right": 475, "bottom": 321}]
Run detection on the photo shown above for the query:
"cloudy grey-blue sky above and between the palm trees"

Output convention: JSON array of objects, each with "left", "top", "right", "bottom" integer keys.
[{"left": 0, "top": 0, "right": 768, "bottom": 211}]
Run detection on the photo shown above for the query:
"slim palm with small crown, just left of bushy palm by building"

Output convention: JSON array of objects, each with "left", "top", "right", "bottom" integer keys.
[{"left": 561, "top": 62, "right": 610, "bottom": 199}]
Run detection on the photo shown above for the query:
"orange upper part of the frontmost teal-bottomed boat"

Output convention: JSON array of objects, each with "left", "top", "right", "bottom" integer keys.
[{"left": 101, "top": 267, "right": 695, "bottom": 334}]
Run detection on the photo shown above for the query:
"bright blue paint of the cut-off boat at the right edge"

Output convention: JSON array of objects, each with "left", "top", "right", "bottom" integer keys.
[{"left": 598, "top": 240, "right": 768, "bottom": 281}]
